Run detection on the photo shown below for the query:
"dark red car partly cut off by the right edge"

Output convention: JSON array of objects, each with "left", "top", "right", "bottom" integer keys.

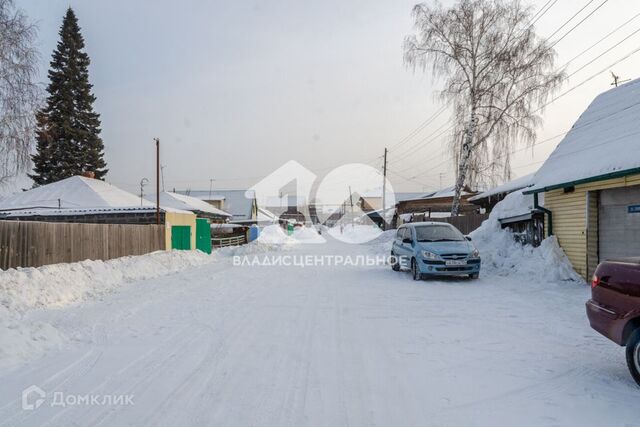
[{"left": 587, "top": 258, "right": 640, "bottom": 385}]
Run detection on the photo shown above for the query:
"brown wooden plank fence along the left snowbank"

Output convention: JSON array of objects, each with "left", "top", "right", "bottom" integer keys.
[{"left": 0, "top": 221, "right": 165, "bottom": 270}]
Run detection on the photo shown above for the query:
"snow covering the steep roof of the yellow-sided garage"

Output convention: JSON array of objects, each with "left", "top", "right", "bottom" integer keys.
[{"left": 526, "top": 79, "right": 640, "bottom": 192}]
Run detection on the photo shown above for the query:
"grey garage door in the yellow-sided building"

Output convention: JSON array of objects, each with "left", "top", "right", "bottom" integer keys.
[{"left": 598, "top": 186, "right": 640, "bottom": 261}]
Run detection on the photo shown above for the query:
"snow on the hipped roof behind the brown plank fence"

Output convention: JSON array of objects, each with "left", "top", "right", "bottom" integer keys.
[{"left": 0, "top": 176, "right": 154, "bottom": 211}]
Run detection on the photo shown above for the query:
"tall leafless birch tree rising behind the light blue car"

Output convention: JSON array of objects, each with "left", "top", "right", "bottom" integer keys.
[{"left": 404, "top": 0, "right": 565, "bottom": 215}]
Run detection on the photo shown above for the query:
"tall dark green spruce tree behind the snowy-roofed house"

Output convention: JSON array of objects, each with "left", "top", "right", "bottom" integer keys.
[{"left": 30, "top": 8, "right": 107, "bottom": 185}]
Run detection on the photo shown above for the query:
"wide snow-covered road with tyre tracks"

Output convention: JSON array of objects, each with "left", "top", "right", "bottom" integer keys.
[{"left": 0, "top": 236, "right": 640, "bottom": 426}]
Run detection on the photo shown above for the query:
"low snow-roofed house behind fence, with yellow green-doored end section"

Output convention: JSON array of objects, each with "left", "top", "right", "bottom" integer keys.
[{"left": 0, "top": 175, "right": 196, "bottom": 249}]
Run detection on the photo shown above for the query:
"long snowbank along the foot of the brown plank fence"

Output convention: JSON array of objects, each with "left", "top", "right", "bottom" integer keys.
[{"left": 0, "top": 251, "right": 215, "bottom": 363}]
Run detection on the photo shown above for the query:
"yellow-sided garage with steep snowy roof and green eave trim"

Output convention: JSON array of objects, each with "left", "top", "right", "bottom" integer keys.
[{"left": 524, "top": 80, "right": 640, "bottom": 278}]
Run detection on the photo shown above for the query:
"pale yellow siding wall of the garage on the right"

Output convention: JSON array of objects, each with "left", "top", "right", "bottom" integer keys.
[{"left": 544, "top": 175, "right": 640, "bottom": 280}]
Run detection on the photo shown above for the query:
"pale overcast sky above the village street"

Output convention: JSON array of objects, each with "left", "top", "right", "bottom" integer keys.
[{"left": 12, "top": 0, "right": 640, "bottom": 196}]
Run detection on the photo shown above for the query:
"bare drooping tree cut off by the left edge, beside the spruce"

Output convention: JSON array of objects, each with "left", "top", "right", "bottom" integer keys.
[{"left": 0, "top": 0, "right": 41, "bottom": 184}]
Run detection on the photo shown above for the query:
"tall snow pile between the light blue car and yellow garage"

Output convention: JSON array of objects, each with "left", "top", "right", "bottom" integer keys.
[{"left": 470, "top": 191, "right": 583, "bottom": 282}]
